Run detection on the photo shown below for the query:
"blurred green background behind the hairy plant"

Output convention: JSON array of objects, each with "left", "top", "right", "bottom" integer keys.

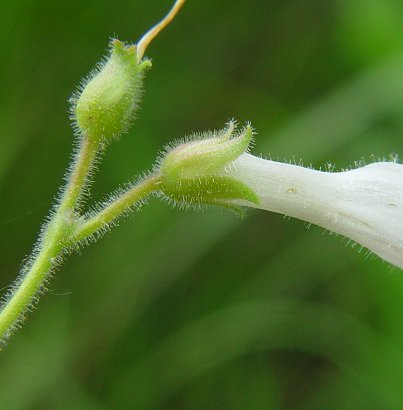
[{"left": 0, "top": 0, "right": 403, "bottom": 410}]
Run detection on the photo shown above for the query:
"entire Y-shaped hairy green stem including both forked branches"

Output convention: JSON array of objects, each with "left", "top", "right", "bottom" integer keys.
[{"left": 0, "top": 138, "right": 160, "bottom": 341}]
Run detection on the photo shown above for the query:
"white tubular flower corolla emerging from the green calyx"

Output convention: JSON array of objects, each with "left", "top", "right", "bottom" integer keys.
[{"left": 228, "top": 153, "right": 403, "bottom": 268}]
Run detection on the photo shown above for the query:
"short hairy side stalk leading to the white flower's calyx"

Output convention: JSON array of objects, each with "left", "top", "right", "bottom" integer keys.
[{"left": 68, "top": 175, "right": 161, "bottom": 246}]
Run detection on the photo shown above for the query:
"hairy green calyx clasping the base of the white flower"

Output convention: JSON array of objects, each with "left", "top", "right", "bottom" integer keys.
[{"left": 159, "top": 122, "right": 259, "bottom": 210}]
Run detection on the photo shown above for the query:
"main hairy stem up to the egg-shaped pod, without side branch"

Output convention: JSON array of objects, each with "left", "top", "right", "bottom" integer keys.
[{"left": 0, "top": 138, "right": 99, "bottom": 340}]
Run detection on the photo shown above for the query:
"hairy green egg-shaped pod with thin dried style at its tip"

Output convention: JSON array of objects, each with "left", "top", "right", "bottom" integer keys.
[{"left": 71, "top": 40, "right": 151, "bottom": 142}]
